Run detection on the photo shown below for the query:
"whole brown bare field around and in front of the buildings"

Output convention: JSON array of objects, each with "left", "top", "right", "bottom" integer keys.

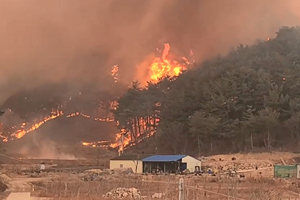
[{"left": 0, "top": 153, "right": 300, "bottom": 200}]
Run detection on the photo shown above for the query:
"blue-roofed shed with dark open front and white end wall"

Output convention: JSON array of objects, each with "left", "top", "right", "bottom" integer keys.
[{"left": 142, "top": 155, "right": 201, "bottom": 173}]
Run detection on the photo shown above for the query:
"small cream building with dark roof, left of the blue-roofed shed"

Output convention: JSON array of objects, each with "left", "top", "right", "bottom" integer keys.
[{"left": 109, "top": 154, "right": 150, "bottom": 173}]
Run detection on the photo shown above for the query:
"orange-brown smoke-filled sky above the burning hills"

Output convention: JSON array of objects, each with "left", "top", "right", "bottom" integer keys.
[{"left": 0, "top": 0, "right": 300, "bottom": 103}]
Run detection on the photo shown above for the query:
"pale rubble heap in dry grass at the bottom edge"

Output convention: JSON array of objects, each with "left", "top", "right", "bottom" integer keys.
[{"left": 103, "top": 187, "right": 143, "bottom": 199}]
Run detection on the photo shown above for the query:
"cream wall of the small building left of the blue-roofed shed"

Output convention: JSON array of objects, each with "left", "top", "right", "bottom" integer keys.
[{"left": 109, "top": 160, "right": 143, "bottom": 173}]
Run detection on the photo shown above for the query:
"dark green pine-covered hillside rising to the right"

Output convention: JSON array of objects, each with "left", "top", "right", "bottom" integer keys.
[{"left": 114, "top": 27, "right": 300, "bottom": 154}]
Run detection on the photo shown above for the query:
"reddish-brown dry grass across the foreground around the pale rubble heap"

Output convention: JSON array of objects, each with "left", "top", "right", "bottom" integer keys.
[{"left": 29, "top": 174, "right": 300, "bottom": 200}]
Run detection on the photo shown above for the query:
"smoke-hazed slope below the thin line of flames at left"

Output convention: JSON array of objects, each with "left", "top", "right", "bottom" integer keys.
[{"left": 0, "top": 113, "right": 118, "bottom": 159}]
